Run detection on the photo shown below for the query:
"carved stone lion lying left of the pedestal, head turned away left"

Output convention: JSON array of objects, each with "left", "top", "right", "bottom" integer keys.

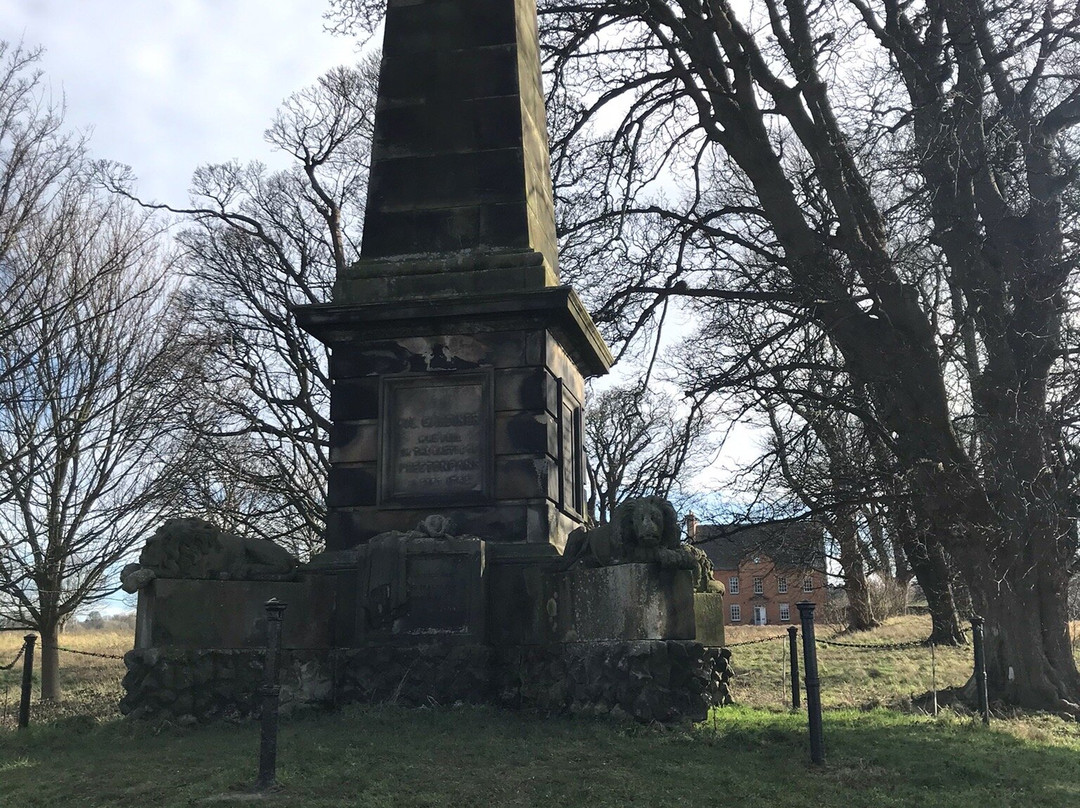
[{"left": 120, "top": 519, "right": 299, "bottom": 592}]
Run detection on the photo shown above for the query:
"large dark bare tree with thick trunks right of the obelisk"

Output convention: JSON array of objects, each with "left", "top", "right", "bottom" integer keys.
[{"left": 533, "top": 0, "right": 1080, "bottom": 710}]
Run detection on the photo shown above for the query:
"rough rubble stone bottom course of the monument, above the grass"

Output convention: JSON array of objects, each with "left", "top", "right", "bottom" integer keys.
[{"left": 120, "top": 639, "right": 730, "bottom": 723}]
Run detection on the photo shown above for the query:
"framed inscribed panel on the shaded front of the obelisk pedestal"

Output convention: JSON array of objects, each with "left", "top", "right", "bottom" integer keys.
[{"left": 379, "top": 371, "right": 494, "bottom": 507}]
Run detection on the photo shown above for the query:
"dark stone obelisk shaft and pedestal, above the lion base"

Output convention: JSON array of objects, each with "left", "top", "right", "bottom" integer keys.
[{"left": 297, "top": 0, "right": 611, "bottom": 561}]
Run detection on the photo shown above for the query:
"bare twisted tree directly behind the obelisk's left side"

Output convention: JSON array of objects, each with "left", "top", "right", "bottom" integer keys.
[{"left": 114, "top": 58, "right": 378, "bottom": 556}]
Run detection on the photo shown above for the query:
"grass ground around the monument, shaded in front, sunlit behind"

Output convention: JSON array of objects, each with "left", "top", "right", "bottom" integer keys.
[{"left": 0, "top": 618, "right": 1080, "bottom": 808}]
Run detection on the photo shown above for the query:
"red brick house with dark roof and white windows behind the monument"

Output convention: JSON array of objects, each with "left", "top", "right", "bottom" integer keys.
[{"left": 687, "top": 513, "right": 827, "bottom": 625}]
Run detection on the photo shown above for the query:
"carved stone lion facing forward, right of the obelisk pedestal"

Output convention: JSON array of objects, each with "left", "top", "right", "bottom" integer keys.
[{"left": 563, "top": 497, "right": 698, "bottom": 570}]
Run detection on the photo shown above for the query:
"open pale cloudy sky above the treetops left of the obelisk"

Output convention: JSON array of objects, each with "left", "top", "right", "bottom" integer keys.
[{"left": 0, "top": 0, "right": 365, "bottom": 204}]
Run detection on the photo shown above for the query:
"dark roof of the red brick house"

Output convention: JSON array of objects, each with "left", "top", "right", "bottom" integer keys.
[{"left": 693, "top": 521, "right": 825, "bottom": 569}]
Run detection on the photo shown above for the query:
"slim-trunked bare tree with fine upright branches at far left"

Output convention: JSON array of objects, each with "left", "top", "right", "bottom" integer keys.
[{"left": 0, "top": 45, "right": 191, "bottom": 698}]
